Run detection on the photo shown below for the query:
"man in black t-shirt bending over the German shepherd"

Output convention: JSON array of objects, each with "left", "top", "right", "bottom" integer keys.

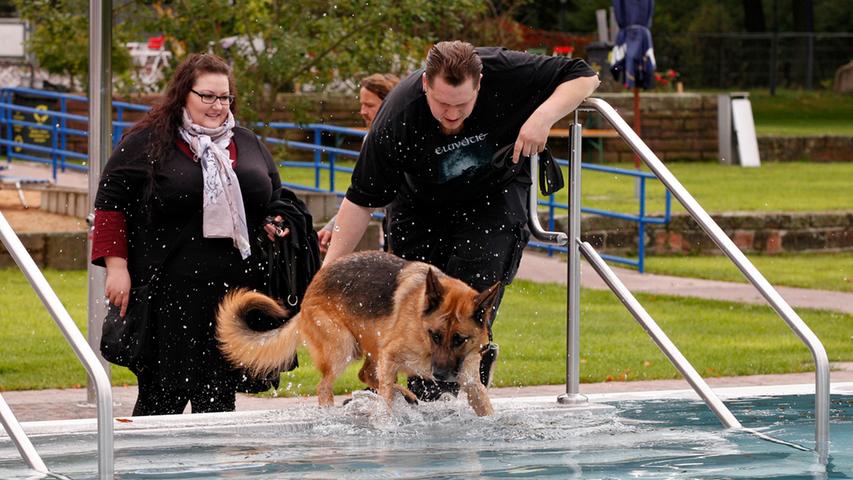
[{"left": 324, "top": 41, "right": 599, "bottom": 400}]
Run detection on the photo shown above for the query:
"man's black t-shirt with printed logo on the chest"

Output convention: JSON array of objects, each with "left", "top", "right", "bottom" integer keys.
[{"left": 346, "top": 47, "right": 595, "bottom": 207}]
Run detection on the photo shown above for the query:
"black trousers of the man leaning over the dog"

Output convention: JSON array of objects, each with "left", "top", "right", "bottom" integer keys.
[{"left": 386, "top": 182, "right": 530, "bottom": 400}]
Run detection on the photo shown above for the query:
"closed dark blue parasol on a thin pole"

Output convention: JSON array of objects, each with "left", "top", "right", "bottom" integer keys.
[{"left": 610, "top": 0, "right": 655, "bottom": 167}]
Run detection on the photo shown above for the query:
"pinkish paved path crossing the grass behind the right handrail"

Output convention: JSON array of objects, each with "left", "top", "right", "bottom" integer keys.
[{"left": 518, "top": 252, "right": 853, "bottom": 314}]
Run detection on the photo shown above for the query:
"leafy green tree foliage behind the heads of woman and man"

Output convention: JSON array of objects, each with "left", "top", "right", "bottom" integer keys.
[{"left": 140, "top": 0, "right": 484, "bottom": 121}]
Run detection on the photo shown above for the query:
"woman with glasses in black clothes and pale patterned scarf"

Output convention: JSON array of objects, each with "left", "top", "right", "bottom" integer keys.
[{"left": 92, "top": 54, "right": 288, "bottom": 415}]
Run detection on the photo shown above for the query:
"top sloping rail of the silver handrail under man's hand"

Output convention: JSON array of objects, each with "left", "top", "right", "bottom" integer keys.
[{"left": 567, "top": 98, "right": 830, "bottom": 464}]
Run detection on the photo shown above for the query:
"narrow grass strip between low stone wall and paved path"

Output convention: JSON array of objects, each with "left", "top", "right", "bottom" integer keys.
[{"left": 646, "top": 252, "right": 853, "bottom": 292}]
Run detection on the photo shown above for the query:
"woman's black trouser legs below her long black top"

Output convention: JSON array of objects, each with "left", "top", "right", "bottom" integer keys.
[{"left": 133, "top": 372, "right": 236, "bottom": 417}]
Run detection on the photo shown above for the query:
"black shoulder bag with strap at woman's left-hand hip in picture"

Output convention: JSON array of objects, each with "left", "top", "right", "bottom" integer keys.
[{"left": 101, "top": 212, "right": 201, "bottom": 373}]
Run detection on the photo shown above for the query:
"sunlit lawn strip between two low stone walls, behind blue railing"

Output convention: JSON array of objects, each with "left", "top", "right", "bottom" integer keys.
[{"left": 281, "top": 162, "right": 853, "bottom": 215}]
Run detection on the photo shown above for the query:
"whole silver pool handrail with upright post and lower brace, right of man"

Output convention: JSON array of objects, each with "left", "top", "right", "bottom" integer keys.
[{"left": 529, "top": 98, "right": 829, "bottom": 465}]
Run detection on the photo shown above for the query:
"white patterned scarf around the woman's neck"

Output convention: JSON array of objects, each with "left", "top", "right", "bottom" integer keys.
[{"left": 178, "top": 109, "right": 251, "bottom": 260}]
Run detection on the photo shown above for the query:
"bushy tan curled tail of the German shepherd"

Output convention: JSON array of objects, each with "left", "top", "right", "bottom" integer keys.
[{"left": 216, "top": 288, "right": 299, "bottom": 376}]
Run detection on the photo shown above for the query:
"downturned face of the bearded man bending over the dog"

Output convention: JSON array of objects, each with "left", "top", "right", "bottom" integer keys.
[{"left": 421, "top": 74, "right": 483, "bottom": 135}]
